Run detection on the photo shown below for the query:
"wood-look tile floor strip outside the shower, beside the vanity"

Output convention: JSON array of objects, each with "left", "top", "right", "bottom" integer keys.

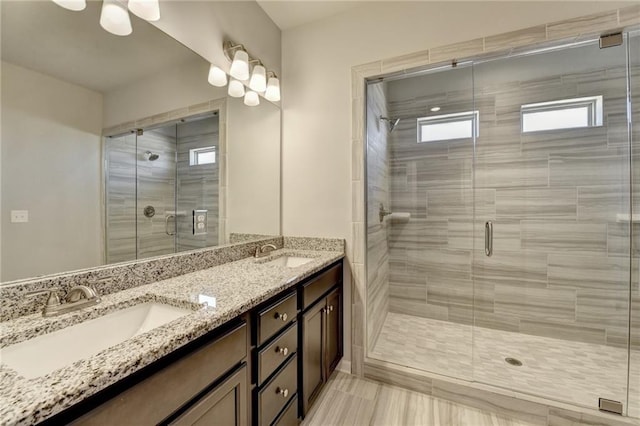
[{"left": 302, "top": 372, "right": 539, "bottom": 426}]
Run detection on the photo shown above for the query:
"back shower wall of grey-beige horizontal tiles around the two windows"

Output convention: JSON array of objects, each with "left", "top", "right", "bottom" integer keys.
[{"left": 388, "top": 62, "right": 640, "bottom": 345}]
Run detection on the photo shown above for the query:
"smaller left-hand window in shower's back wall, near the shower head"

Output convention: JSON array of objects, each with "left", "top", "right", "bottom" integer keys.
[{"left": 418, "top": 111, "right": 478, "bottom": 143}]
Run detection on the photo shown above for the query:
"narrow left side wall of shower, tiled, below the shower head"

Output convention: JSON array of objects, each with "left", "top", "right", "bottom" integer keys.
[{"left": 367, "top": 84, "right": 391, "bottom": 348}]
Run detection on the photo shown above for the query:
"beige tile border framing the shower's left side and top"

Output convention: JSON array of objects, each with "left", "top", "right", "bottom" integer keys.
[{"left": 347, "top": 6, "right": 640, "bottom": 376}]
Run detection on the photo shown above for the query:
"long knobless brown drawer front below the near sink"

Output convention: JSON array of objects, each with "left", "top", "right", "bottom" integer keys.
[{"left": 73, "top": 322, "right": 247, "bottom": 425}]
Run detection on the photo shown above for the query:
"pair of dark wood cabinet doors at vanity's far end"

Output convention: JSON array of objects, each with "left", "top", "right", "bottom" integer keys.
[{"left": 301, "top": 283, "right": 342, "bottom": 416}]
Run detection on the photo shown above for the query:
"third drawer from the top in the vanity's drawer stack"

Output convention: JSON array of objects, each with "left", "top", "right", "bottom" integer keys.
[{"left": 258, "top": 356, "right": 298, "bottom": 425}]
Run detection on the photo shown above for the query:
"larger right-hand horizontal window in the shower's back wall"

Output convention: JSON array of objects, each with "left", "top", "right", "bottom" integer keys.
[{"left": 520, "top": 96, "right": 602, "bottom": 133}]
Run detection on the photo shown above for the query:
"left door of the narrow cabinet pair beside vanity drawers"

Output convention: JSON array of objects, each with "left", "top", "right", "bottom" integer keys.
[{"left": 302, "top": 299, "right": 325, "bottom": 414}]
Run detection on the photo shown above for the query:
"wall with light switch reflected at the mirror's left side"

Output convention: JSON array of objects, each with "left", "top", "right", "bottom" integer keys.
[{"left": 0, "top": 62, "right": 103, "bottom": 281}]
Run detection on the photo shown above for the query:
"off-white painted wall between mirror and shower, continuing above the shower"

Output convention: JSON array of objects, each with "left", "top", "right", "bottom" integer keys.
[{"left": 282, "top": 1, "right": 632, "bottom": 359}]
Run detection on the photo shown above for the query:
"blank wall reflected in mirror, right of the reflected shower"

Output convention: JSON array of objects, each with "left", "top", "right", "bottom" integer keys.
[{"left": 227, "top": 98, "right": 280, "bottom": 235}]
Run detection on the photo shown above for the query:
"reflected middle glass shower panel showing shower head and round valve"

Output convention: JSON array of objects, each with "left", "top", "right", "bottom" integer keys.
[{"left": 136, "top": 124, "right": 179, "bottom": 259}]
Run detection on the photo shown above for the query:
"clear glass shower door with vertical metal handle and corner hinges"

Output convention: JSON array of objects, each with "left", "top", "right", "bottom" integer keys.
[{"left": 473, "top": 37, "right": 631, "bottom": 409}]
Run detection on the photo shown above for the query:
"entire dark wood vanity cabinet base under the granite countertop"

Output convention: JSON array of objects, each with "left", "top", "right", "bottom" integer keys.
[{"left": 53, "top": 260, "right": 343, "bottom": 426}]
